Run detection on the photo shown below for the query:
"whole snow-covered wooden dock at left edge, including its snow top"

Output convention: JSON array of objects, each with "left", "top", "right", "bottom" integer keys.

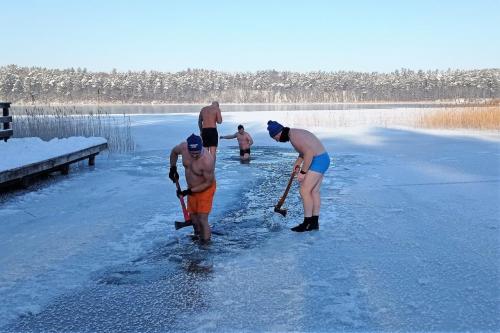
[{"left": 0, "top": 137, "right": 108, "bottom": 188}]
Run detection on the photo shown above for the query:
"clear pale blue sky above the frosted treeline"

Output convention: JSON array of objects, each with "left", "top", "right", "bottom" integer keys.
[{"left": 0, "top": 0, "right": 500, "bottom": 72}]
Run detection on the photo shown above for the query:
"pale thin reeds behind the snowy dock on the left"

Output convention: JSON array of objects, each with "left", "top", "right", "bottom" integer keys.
[{"left": 12, "top": 106, "right": 135, "bottom": 152}]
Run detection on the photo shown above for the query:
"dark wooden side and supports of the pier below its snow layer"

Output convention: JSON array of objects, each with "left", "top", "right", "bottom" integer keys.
[{"left": 0, "top": 143, "right": 108, "bottom": 189}]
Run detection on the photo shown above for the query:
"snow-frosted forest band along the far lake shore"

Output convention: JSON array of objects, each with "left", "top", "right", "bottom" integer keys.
[{"left": 0, "top": 65, "right": 500, "bottom": 104}]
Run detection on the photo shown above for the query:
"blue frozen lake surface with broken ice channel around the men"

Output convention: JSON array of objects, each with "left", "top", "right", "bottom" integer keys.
[{"left": 0, "top": 112, "right": 500, "bottom": 332}]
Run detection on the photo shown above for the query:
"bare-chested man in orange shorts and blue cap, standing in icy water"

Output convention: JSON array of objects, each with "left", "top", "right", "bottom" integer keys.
[{"left": 168, "top": 134, "right": 216, "bottom": 243}]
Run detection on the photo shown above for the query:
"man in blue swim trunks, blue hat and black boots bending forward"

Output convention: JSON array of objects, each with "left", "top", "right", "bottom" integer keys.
[{"left": 267, "top": 120, "right": 330, "bottom": 232}]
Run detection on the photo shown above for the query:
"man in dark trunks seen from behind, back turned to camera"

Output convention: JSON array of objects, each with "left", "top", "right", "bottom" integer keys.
[{"left": 198, "top": 102, "right": 222, "bottom": 160}]
